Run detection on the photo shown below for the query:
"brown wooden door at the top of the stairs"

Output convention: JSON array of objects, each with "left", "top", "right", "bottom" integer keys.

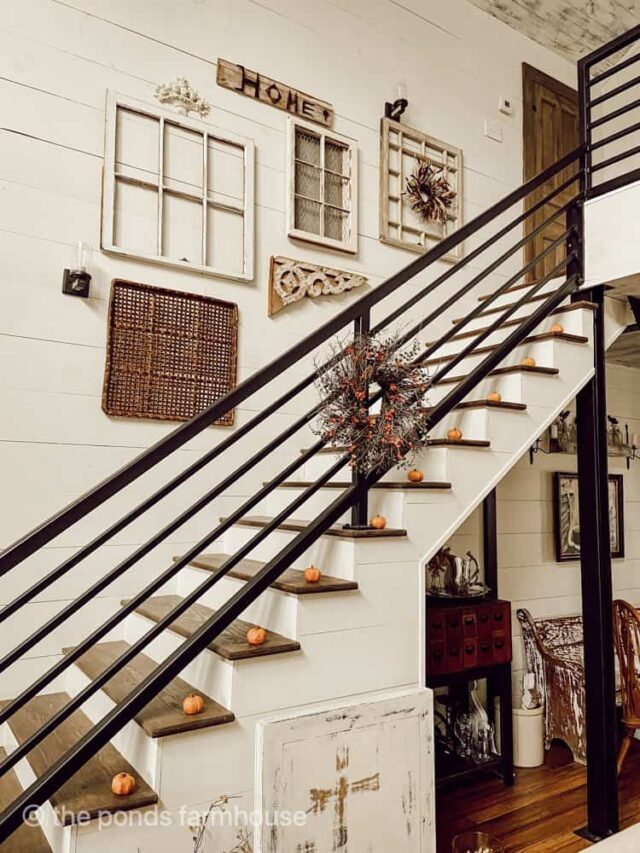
[{"left": 522, "top": 63, "right": 579, "bottom": 281}]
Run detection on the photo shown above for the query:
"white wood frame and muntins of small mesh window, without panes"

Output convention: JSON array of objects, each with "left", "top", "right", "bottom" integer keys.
[{"left": 287, "top": 116, "right": 358, "bottom": 254}]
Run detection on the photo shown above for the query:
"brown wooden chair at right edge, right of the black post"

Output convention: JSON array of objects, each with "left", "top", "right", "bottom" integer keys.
[{"left": 613, "top": 599, "right": 640, "bottom": 773}]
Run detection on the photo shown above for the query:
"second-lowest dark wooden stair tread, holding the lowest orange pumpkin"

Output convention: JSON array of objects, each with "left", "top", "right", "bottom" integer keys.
[{"left": 4, "top": 693, "right": 158, "bottom": 825}]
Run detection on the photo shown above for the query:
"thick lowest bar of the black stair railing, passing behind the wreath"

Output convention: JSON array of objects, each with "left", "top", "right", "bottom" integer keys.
[{"left": 0, "top": 276, "right": 576, "bottom": 838}]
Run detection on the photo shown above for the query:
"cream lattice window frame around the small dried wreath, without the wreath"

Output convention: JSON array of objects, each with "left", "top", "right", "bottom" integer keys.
[{"left": 380, "top": 118, "right": 463, "bottom": 261}]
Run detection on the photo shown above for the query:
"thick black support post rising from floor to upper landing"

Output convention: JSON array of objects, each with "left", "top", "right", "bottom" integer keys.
[{"left": 577, "top": 286, "right": 618, "bottom": 840}]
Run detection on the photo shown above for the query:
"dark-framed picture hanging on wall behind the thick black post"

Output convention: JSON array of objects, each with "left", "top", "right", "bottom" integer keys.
[{"left": 553, "top": 471, "right": 624, "bottom": 562}]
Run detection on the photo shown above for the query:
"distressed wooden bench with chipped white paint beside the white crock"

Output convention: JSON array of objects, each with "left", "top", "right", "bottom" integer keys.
[{"left": 517, "top": 608, "right": 587, "bottom": 764}]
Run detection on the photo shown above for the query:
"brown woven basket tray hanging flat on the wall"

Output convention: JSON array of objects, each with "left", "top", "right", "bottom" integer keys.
[{"left": 102, "top": 279, "right": 238, "bottom": 426}]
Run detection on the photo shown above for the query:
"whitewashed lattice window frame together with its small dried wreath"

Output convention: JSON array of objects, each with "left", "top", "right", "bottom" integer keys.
[{"left": 380, "top": 118, "right": 463, "bottom": 261}]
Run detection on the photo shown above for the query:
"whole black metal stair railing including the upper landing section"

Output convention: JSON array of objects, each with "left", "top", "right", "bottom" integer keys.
[{"left": 0, "top": 20, "right": 640, "bottom": 841}]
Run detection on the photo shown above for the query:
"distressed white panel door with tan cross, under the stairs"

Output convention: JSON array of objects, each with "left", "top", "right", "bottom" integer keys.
[{"left": 255, "top": 689, "right": 436, "bottom": 853}]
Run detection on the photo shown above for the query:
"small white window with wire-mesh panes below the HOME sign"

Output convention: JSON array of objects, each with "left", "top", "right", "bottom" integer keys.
[{"left": 287, "top": 117, "right": 358, "bottom": 254}]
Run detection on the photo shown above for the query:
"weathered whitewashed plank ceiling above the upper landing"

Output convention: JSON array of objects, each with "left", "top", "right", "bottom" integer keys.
[{"left": 471, "top": 0, "right": 640, "bottom": 61}]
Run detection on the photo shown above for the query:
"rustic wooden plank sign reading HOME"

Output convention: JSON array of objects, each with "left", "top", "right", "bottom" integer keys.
[{"left": 216, "top": 59, "right": 333, "bottom": 127}]
